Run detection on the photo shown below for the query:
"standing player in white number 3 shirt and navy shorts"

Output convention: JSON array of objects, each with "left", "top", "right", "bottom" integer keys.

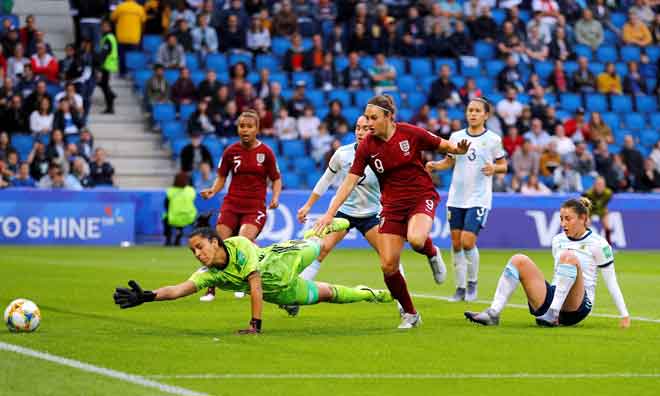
[{"left": 426, "top": 98, "right": 507, "bottom": 301}]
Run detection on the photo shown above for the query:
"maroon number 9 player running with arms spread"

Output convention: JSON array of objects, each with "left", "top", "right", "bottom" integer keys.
[{"left": 314, "top": 95, "right": 470, "bottom": 329}]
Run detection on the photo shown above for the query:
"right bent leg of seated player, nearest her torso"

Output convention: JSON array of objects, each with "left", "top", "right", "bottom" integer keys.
[{"left": 536, "top": 251, "right": 584, "bottom": 326}]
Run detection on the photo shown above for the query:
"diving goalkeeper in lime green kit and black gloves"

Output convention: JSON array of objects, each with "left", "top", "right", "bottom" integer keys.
[{"left": 113, "top": 214, "right": 392, "bottom": 334}]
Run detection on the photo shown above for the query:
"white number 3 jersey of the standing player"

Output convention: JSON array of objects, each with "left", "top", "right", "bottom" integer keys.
[{"left": 447, "top": 129, "right": 506, "bottom": 209}]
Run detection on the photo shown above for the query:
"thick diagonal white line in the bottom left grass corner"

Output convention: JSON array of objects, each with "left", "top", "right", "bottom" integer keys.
[{"left": 0, "top": 341, "right": 208, "bottom": 396}]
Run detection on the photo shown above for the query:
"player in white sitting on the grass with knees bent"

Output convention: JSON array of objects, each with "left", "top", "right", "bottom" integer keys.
[{"left": 465, "top": 198, "right": 630, "bottom": 328}]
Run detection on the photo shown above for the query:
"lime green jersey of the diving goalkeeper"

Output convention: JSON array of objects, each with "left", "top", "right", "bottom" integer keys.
[{"left": 189, "top": 236, "right": 320, "bottom": 295}]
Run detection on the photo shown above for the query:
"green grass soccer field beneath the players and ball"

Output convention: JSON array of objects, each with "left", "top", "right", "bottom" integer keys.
[{"left": 0, "top": 246, "right": 660, "bottom": 396}]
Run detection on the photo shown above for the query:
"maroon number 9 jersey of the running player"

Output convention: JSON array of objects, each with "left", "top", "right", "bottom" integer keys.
[{"left": 350, "top": 122, "right": 442, "bottom": 210}]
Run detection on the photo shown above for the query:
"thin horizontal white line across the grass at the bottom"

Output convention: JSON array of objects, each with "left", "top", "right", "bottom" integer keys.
[{"left": 148, "top": 373, "right": 660, "bottom": 380}]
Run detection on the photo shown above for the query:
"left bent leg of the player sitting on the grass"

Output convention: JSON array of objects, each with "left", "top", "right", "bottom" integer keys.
[{"left": 465, "top": 254, "right": 551, "bottom": 325}]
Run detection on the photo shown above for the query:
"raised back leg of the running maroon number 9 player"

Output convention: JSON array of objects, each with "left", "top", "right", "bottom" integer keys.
[{"left": 407, "top": 212, "right": 447, "bottom": 284}]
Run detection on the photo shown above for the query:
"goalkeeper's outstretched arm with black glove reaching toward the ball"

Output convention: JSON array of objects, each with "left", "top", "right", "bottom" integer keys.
[{"left": 113, "top": 280, "right": 197, "bottom": 309}]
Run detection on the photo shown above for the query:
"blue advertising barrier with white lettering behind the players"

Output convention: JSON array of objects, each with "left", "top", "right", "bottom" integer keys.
[{"left": 0, "top": 189, "right": 660, "bottom": 249}]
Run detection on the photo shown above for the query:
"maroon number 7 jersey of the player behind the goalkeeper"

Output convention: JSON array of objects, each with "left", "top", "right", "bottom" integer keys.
[{"left": 218, "top": 143, "right": 280, "bottom": 212}]
